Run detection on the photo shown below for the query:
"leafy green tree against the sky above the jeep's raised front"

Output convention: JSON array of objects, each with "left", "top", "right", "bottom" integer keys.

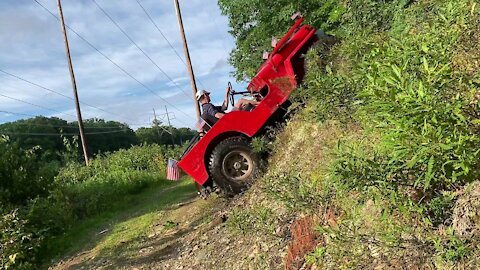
[{"left": 218, "top": 0, "right": 344, "bottom": 81}]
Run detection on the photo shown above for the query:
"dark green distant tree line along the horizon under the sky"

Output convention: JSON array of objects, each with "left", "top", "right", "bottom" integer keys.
[{"left": 0, "top": 116, "right": 196, "bottom": 161}]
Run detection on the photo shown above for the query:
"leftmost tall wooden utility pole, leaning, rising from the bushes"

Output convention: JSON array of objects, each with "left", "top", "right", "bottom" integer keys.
[{"left": 57, "top": 0, "right": 89, "bottom": 166}]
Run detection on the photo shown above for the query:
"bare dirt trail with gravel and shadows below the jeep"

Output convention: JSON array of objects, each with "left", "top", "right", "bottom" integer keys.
[{"left": 50, "top": 184, "right": 287, "bottom": 270}]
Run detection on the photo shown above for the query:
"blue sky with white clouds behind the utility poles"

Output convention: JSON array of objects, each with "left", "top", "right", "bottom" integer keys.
[{"left": 0, "top": 0, "right": 246, "bottom": 129}]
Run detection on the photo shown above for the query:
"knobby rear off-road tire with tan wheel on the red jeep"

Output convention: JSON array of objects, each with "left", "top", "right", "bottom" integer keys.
[{"left": 209, "top": 137, "right": 260, "bottom": 196}]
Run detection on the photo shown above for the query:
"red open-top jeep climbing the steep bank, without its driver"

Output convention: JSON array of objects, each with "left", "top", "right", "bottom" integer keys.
[{"left": 178, "top": 15, "right": 332, "bottom": 194}]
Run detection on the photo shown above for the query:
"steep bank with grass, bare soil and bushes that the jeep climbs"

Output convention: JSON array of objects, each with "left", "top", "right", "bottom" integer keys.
[{"left": 229, "top": 0, "right": 480, "bottom": 269}]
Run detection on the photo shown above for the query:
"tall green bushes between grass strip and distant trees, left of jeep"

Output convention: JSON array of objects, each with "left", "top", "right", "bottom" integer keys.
[{"left": 39, "top": 145, "right": 166, "bottom": 220}]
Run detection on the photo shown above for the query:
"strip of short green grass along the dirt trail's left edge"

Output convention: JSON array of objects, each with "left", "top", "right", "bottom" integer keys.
[{"left": 43, "top": 179, "right": 196, "bottom": 262}]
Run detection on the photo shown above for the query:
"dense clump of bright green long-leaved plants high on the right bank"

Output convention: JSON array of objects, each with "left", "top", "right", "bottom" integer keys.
[{"left": 354, "top": 1, "right": 480, "bottom": 189}]
